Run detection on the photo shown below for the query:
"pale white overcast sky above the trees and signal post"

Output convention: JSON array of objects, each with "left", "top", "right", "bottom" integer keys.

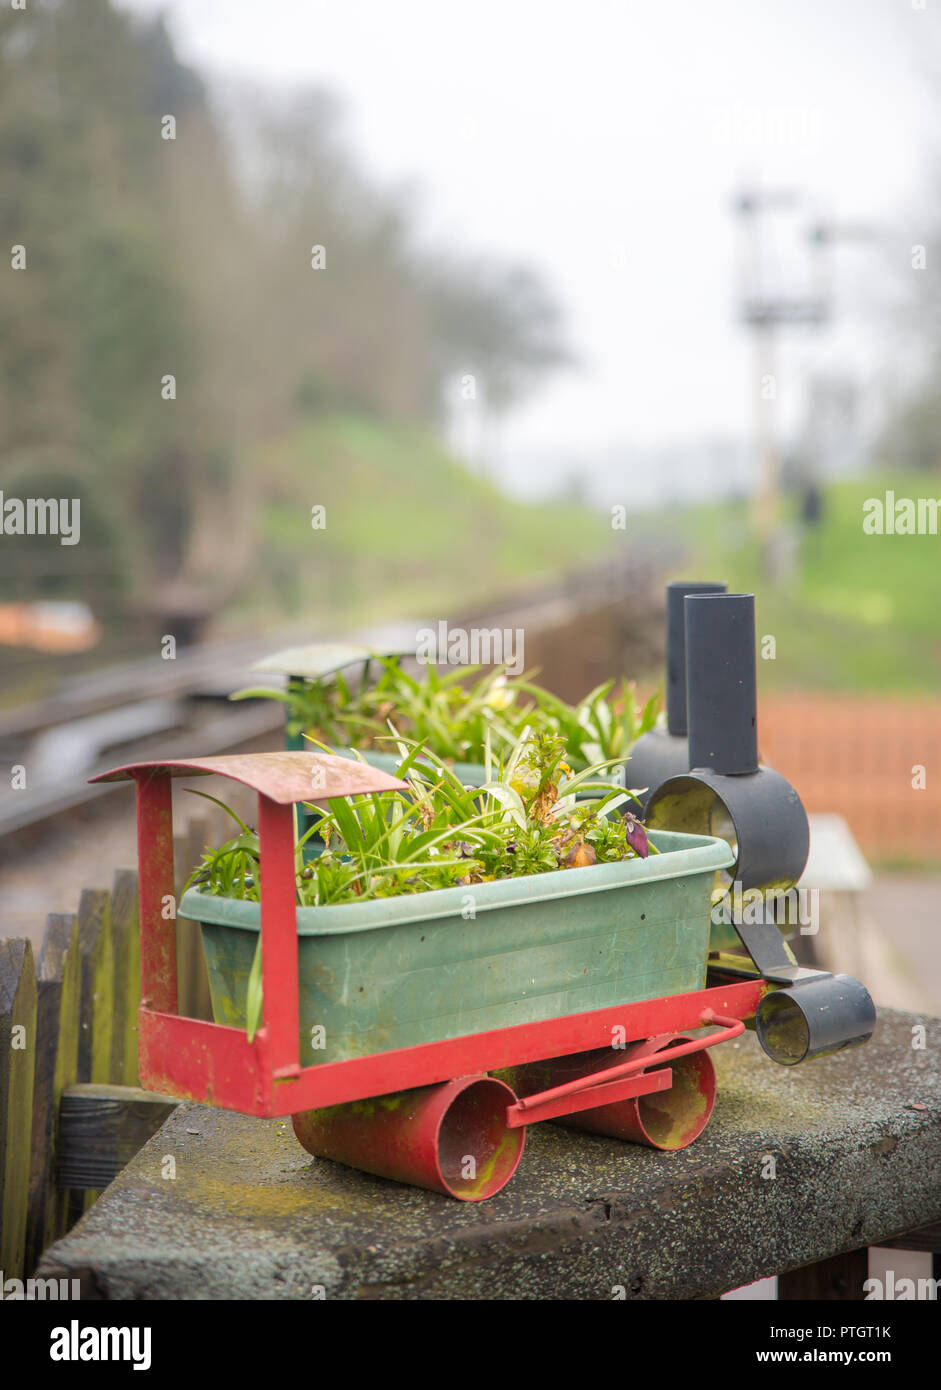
[{"left": 121, "top": 0, "right": 941, "bottom": 500}]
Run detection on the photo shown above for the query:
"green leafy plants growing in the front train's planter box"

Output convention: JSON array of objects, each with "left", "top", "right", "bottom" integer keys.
[{"left": 189, "top": 730, "right": 649, "bottom": 906}]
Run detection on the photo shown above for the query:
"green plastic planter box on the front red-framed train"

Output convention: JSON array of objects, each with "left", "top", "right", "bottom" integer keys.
[{"left": 179, "top": 830, "right": 734, "bottom": 1066}]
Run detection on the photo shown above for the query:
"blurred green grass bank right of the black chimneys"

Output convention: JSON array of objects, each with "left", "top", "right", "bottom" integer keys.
[{"left": 661, "top": 473, "right": 941, "bottom": 696}]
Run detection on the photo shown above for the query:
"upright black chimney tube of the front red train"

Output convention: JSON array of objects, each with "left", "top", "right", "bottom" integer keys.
[{"left": 684, "top": 594, "right": 758, "bottom": 776}]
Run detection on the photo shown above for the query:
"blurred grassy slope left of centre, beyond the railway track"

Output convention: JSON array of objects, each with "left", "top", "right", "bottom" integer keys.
[{"left": 244, "top": 417, "right": 614, "bottom": 620}]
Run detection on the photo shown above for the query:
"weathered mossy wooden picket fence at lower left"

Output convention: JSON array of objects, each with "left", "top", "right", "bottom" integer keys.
[{"left": 0, "top": 808, "right": 231, "bottom": 1279}]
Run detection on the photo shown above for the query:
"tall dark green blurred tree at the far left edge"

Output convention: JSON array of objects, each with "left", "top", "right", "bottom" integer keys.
[{"left": 0, "top": 0, "right": 209, "bottom": 608}]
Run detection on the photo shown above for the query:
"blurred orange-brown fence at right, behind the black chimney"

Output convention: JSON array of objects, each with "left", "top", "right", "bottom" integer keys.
[{"left": 758, "top": 695, "right": 941, "bottom": 862}]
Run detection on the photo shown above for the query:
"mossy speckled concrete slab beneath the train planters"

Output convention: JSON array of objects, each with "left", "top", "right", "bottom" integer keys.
[{"left": 39, "top": 1011, "right": 941, "bottom": 1300}]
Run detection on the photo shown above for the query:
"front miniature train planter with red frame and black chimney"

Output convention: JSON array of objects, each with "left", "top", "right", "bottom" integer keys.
[{"left": 152, "top": 582, "right": 876, "bottom": 1201}]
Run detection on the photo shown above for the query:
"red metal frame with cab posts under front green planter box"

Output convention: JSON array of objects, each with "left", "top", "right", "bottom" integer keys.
[{"left": 108, "top": 755, "right": 767, "bottom": 1125}]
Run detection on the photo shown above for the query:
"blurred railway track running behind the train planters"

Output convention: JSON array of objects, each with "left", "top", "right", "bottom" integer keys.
[{"left": 0, "top": 543, "right": 681, "bottom": 849}]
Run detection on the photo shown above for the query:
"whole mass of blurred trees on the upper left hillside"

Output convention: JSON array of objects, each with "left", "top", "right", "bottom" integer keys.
[{"left": 0, "top": 0, "right": 564, "bottom": 613}]
